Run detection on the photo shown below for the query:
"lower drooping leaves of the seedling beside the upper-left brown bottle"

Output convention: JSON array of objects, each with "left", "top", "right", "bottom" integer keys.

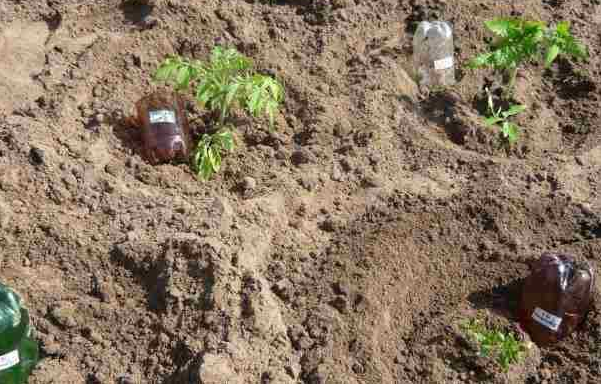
[{"left": 192, "top": 128, "right": 234, "bottom": 181}]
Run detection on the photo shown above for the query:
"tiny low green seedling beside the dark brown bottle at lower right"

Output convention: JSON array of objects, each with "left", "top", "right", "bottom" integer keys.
[{"left": 462, "top": 319, "right": 528, "bottom": 371}]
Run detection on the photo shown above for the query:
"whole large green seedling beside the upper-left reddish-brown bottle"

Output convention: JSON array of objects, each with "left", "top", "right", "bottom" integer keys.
[{"left": 154, "top": 46, "right": 284, "bottom": 180}]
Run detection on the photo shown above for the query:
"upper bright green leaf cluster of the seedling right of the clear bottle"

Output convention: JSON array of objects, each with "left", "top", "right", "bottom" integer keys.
[{"left": 468, "top": 18, "right": 588, "bottom": 94}]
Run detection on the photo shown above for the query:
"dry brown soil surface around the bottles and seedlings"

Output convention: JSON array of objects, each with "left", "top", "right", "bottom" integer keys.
[{"left": 0, "top": 0, "right": 601, "bottom": 384}]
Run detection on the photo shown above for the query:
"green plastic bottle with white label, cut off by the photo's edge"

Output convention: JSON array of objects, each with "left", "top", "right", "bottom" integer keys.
[{"left": 0, "top": 283, "right": 39, "bottom": 384}]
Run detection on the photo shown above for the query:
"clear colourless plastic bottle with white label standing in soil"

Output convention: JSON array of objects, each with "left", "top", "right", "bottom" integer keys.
[{"left": 413, "top": 21, "right": 455, "bottom": 87}]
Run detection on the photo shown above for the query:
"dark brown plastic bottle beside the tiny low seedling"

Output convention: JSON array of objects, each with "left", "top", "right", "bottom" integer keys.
[{"left": 519, "top": 253, "right": 594, "bottom": 346}]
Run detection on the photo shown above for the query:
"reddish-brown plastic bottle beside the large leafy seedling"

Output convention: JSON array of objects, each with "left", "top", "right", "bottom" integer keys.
[{"left": 136, "top": 91, "right": 190, "bottom": 164}]
